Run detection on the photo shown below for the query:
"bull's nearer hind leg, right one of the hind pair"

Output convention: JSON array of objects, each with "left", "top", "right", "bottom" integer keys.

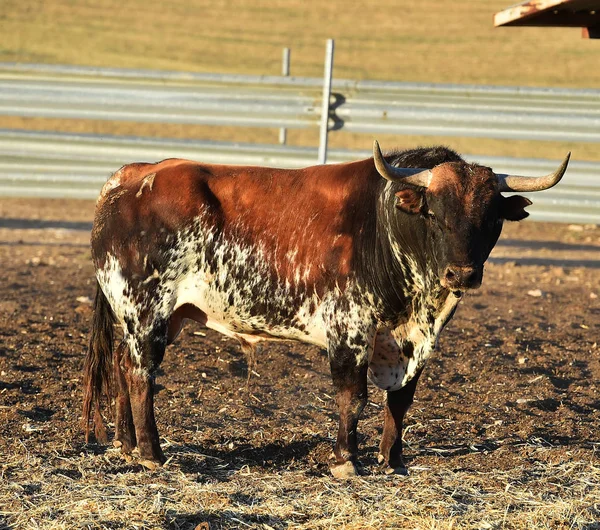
[{"left": 125, "top": 322, "right": 167, "bottom": 469}]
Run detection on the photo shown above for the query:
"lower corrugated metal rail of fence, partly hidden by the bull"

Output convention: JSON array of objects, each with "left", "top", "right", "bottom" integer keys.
[{"left": 0, "top": 130, "right": 600, "bottom": 224}]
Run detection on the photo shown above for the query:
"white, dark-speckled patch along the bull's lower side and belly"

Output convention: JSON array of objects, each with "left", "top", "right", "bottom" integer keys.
[{"left": 97, "top": 212, "right": 372, "bottom": 370}]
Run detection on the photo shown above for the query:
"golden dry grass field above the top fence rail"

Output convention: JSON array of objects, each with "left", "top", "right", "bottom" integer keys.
[{"left": 0, "top": 0, "right": 600, "bottom": 88}]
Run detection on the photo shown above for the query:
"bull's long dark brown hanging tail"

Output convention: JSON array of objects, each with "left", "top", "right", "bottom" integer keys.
[{"left": 83, "top": 282, "right": 115, "bottom": 443}]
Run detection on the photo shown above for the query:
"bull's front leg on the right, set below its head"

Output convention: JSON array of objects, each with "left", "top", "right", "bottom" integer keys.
[{"left": 379, "top": 371, "right": 421, "bottom": 475}]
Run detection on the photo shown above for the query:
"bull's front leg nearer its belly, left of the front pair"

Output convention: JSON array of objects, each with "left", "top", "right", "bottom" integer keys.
[{"left": 329, "top": 337, "right": 370, "bottom": 478}]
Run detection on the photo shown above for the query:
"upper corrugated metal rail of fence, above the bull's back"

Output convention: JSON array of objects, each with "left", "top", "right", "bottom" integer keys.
[{"left": 0, "top": 64, "right": 600, "bottom": 143}]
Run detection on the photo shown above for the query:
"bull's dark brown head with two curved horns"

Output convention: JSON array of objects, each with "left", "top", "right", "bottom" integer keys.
[{"left": 373, "top": 141, "right": 570, "bottom": 291}]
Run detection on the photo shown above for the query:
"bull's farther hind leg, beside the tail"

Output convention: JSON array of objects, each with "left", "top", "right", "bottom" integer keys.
[{"left": 113, "top": 341, "right": 137, "bottom": 456}]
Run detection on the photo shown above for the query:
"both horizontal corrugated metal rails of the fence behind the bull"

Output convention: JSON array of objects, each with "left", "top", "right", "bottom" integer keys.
[{"left": 0, "top": 59, "right": 600, "bottom": 224}]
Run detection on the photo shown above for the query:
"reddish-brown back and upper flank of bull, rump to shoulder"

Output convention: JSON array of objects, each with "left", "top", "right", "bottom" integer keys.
[{"left": 92, "top": 159, "right": 372, "bottom": 281}]
